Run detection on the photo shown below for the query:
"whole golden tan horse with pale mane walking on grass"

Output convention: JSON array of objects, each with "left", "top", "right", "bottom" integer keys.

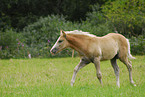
[{"left": 50, "top": 30, "right": 136, "bottom": 87}]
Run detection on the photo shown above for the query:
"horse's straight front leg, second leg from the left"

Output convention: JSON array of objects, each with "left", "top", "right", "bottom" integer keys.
[{"left": 94, "top": 57, "right": 103, "bottom": 84}]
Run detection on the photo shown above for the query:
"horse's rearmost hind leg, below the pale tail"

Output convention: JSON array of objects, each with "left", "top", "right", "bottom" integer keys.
[{"left": 119, "top": 57, "right": 136, "bottom": 86}]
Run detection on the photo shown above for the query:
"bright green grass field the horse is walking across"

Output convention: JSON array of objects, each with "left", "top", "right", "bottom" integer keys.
[{"left": 0, "top": 56, "right": 145, "bottom": 97}]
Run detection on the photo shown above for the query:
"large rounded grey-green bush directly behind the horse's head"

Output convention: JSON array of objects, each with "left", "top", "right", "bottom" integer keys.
[{"left": 23, "top": 15, "right": 80, "bottom": 57}]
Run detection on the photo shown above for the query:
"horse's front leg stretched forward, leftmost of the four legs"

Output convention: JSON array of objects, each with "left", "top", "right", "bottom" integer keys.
[{"left": 71, "top": 58, "right": 90, "bottom": 86}]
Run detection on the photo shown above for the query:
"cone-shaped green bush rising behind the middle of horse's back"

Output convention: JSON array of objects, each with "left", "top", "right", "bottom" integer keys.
[{"left": 80, "top": 4, "right": 113, "bottom": 36}]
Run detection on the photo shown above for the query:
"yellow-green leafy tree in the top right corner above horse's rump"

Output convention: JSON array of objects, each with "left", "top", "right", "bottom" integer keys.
[{"left": 102, "top": 0, "right": 145, "bottom": 36}]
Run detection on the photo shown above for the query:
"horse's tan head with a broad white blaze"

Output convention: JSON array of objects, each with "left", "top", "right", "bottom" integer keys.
[{"left": 50, "top": 30, "right": 68, "bottom": 54}]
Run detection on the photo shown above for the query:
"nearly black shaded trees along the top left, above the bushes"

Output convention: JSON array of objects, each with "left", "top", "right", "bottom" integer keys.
[{"left": 0, "top": 0, "right": 108, "bottom": 29}]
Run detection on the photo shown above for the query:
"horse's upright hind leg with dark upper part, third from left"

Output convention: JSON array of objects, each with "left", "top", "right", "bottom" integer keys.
[{"left": 111, "top": 58, "right": 120, "bottom": 87}]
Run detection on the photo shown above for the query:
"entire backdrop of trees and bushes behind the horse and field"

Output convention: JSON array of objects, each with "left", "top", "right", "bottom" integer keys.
[{"left": 0, "top": 0, "right": 145, "bottom": 58}]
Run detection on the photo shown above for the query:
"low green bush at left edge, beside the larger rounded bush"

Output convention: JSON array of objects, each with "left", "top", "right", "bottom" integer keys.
[{"left": 0, "top": 29, "right": 25, "bottom": 59}]
